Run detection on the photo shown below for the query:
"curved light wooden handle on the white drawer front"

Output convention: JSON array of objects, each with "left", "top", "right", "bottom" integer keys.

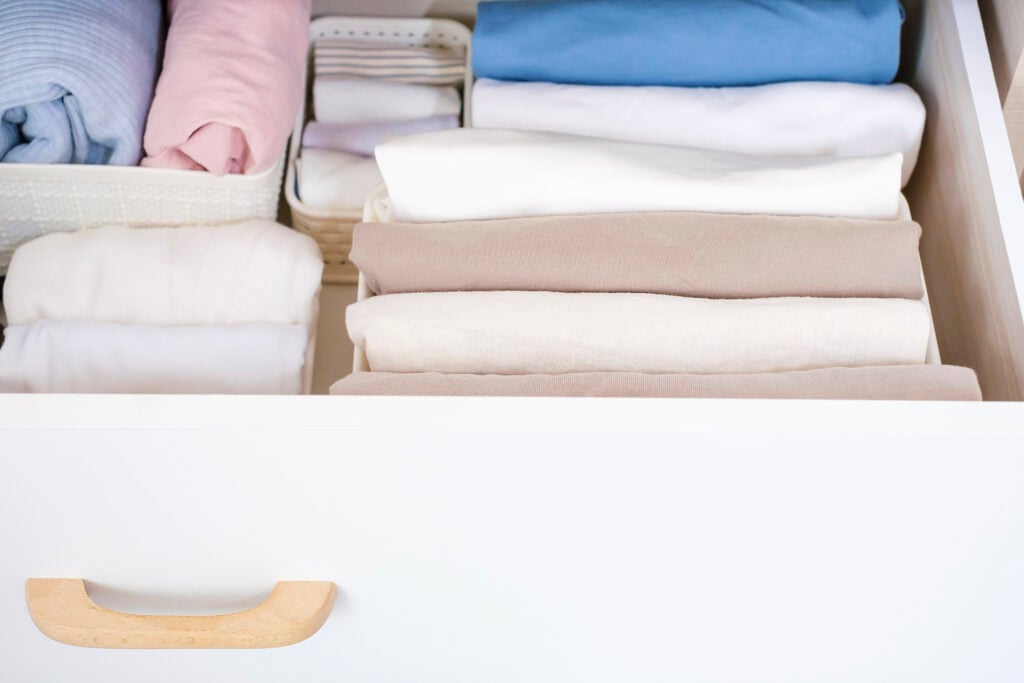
[{"left": 25, "top": 579, "right": 335, "bottom": 649}]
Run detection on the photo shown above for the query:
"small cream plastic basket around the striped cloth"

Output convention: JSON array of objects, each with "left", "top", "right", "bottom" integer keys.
[{"left": 285, "top": 16, "right": 473, "bottom": 285}]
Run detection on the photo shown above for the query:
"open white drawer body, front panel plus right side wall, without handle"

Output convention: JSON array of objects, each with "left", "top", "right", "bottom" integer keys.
[{"left": 0, "top": 0, "right": 1024, "bottom": 683}]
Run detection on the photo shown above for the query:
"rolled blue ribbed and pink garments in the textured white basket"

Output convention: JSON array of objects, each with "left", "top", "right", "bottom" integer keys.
[{"left": 0, "top": 0, "right": 309, "bottom": 175}]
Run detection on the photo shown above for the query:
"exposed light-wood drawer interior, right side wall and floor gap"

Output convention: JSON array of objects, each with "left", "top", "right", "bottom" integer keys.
[{"left": 6, "top": 0, "right": 1024, "bottom": 400}]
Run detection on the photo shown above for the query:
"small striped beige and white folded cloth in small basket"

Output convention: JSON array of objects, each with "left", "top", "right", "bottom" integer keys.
[{"left": 313, "top": 39, "right": 466, "bottom": 85}]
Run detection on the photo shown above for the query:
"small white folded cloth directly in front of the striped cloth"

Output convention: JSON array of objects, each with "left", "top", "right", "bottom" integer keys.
[{"left": 313, "top": 76, "right": 462, "bottom": 123}]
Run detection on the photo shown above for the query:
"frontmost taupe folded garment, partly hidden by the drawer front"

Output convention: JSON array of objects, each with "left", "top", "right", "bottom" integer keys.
[{"left": 331, "top": 366, "right": 981, "bottom": 400}]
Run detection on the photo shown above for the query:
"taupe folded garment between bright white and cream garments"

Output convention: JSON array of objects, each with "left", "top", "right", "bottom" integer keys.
[{"left": 351, "top": 213, "right": 924, "bottom": 299}]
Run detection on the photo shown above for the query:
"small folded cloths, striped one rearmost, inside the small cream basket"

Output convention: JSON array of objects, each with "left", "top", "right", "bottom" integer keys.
[{"left": 295, "top": 39, "right": 466, "bottom": 211}]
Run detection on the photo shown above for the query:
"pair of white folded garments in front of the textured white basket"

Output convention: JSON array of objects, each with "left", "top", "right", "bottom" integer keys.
[{"left": 0, "top": 220, "right": 323, "bottom": 394}]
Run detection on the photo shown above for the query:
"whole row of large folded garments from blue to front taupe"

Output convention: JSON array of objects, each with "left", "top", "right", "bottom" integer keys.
[{"left": 333, "top": 0, "right": 980, "bottom": 400}]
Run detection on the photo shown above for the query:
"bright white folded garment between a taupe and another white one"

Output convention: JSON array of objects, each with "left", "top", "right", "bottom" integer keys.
[{"left": 377, "top": 128, "right": 902, "bottom": 222}]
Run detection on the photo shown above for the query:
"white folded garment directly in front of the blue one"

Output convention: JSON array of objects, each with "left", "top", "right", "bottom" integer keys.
[{"left": 473, "top": 79, "right": 925, "bottom": 185}]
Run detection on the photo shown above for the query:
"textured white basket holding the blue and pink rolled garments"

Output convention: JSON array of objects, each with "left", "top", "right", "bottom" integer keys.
[{"left": 0, "top": 157, "right": 284, "bottom": 274}]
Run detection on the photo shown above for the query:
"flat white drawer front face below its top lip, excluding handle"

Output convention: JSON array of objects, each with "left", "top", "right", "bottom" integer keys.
[{"left": 0, "top": 423, "right": 1024, "bottom": 683}]
